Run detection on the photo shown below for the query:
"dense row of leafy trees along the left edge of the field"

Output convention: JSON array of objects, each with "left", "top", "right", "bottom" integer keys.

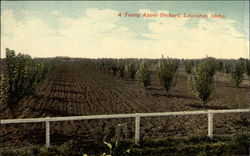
[{"left": 0, "top": 49, "right": 55, "bottom": 108}]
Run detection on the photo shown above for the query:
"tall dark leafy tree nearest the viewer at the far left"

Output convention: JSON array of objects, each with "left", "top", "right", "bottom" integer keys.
[{"left": 1, "top": 49, "right": 31, "bottom": 106}]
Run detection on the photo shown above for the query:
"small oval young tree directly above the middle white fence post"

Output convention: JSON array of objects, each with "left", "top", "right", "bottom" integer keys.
[{"left": 137, "top": 62, "right": 151, "bottom": 88}]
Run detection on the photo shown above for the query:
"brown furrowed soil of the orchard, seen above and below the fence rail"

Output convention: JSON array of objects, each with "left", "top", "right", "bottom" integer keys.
[{"left": 0, "top": 61, "right": 250, "bottom": 147}]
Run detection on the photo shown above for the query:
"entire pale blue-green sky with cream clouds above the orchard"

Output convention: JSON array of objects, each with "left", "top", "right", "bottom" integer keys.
[{"left": 1, "top": 1, "right": 250, "bottom": 59}]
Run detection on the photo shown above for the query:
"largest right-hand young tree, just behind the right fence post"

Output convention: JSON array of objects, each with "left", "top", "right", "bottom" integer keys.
[{"left": 188, "top": 62, "right": 213, "bottom": 107}]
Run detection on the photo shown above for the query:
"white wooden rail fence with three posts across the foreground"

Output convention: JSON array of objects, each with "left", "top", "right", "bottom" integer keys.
[{"left": 0, "top": 109, "right": 250, "bottom": 147}]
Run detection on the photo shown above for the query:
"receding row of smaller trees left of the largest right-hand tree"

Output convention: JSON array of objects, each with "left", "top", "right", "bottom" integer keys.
[{"left": 89, "top": 58, "right": 180, "bottom": 91}]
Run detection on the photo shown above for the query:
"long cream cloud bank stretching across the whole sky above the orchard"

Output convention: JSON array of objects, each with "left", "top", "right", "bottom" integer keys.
[{"left": 1, "top": 8, "right": 249, "bottom": 58}]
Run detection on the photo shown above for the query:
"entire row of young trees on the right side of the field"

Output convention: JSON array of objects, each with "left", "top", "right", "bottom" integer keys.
[{"left": 91, "top": 57, "right": 250, "bottom": 109}]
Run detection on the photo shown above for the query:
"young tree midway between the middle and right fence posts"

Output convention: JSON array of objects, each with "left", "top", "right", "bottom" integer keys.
[{"left": 156, "top": 60, "right": 177, "bottom": 91}]
